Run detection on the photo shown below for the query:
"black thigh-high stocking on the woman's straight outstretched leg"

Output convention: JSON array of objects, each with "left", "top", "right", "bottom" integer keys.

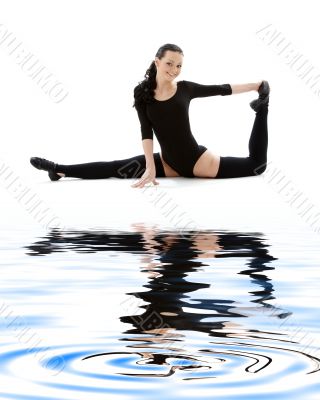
[{"left": 56, "top": 153, "right": 165, "bottom": 179}]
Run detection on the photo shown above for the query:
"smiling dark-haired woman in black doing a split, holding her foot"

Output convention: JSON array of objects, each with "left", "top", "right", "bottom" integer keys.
[{"left": 30, "top": 43, "right": 270, "bottom": 188}]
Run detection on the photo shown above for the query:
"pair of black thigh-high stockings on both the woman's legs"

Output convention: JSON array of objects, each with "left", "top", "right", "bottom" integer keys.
[{"left": 56, "top": 105, "right": 268, "bottom": 179}]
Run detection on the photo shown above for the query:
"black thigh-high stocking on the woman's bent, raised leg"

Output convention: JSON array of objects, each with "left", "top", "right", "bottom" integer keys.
[{"left": 215, "top": 105, "right": 269, "bottom": 179}]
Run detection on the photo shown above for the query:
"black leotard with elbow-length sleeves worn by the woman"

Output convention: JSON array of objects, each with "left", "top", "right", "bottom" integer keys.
[{"left": 137, "top": 80, "right": 232, "bottom": 177}]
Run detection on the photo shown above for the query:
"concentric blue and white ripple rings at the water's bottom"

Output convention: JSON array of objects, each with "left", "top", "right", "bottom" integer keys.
[{"left": 0, "top": 341, "right": 320, "bottom": 398}]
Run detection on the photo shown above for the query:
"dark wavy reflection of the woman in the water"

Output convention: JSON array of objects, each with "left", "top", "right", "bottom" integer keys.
[{"left": 26, "top": 224, "right": 319, "bottom": 379}]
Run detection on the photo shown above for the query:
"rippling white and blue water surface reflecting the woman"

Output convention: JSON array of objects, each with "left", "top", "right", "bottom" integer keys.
[{"left": 0, "top": 224, "right": 320, "bottom": 399}]
